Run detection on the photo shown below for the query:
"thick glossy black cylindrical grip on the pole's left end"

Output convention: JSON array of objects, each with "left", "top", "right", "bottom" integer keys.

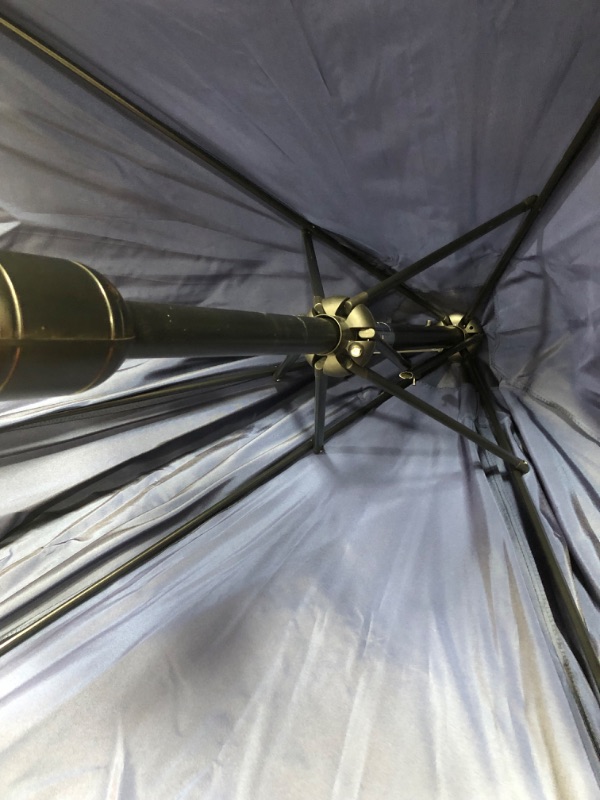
[{"left": 0, "top": 252, "right": 131, "bottom": 399}]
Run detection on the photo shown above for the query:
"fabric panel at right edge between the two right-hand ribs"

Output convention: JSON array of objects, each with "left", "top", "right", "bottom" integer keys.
[{"left": 490, "top": 126, "right": 600, "bottom": 643}]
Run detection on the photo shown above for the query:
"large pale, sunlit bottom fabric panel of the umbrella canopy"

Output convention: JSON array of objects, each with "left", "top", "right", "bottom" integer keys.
[{"left": 0, "top": 404, "right": 596, "bottom": 798}]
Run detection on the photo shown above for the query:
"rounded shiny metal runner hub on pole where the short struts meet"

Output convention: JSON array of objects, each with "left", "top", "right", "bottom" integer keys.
[{"left": 306, "top": 295, "right": 375, "bottom": 378}]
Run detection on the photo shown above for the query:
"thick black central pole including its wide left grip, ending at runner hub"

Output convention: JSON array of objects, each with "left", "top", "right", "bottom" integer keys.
[{"left": 0, "top": 252, "right": 341, "bottom": 398}]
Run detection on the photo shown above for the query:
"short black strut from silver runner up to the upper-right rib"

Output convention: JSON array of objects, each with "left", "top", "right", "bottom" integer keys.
[{"left": 349, "top": 195, "right": 537, "bottom": 308}]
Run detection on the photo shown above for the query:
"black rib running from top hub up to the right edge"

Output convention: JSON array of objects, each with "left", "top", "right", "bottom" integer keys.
[{"left": 460, "top": 98, "right": 600, "bottom": 326}]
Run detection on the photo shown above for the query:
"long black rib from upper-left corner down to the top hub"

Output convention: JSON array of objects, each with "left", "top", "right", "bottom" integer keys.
[{"left": 0, "top": 14, "right": 440, "bottom": 320}]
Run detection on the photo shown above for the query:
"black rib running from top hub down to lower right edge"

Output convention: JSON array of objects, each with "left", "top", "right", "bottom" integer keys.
[{"left": 465, "top": 358, "right": 600, "bottom": 699}]
